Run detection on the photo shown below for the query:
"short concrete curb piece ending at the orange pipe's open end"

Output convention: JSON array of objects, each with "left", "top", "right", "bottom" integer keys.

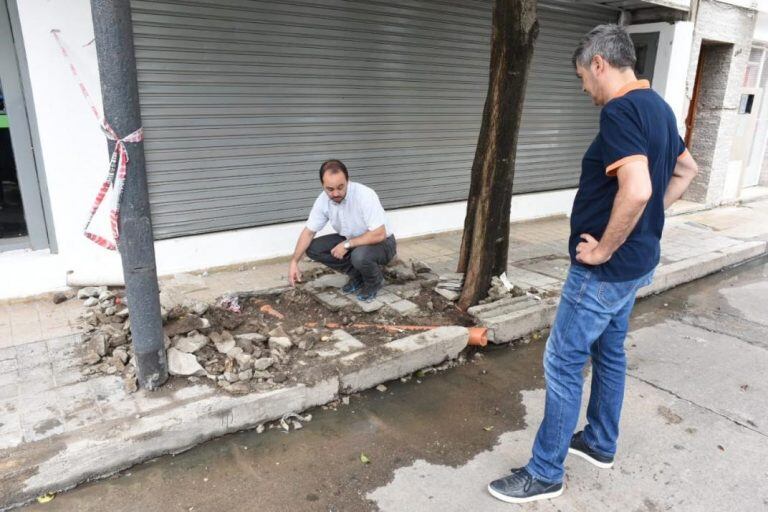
[{"left": 341, "top": 326, "right": 469, "bottom": 393}]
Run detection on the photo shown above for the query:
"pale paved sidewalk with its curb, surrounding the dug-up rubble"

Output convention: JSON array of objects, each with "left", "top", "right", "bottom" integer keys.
[{"left": 0, "top": 200, "right": 768, "bottom": 509}]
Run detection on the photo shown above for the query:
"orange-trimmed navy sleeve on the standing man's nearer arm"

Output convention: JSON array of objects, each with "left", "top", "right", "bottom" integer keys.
[{"left": 600, "top": 102, "right": 648, "bottom": 176}]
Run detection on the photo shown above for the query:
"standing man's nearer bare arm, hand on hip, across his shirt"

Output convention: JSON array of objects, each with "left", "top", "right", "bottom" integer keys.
[{"left": 576, "top": 160, "right": 653, "bottom": 265}]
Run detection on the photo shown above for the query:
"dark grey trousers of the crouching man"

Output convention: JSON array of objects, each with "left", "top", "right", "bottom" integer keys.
[{"left": 307, "top": 234, "right": 397, "bottom": 288}]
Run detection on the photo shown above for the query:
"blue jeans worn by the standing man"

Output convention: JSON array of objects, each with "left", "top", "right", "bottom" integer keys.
[{"left": 526, "top": 265, "right": 653, "bottom": 483}]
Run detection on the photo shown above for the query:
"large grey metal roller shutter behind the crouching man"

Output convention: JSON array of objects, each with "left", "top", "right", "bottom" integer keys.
[{"left": 131, "top": 0, "right": 615, "bottom": 239}]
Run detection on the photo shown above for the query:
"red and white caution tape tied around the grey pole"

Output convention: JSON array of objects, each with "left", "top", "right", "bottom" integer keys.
[{"left": 51, "top": 29, "right": 144, "bottom": 251}]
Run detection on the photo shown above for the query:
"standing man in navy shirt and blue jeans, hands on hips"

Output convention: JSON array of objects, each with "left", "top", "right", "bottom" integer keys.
[{"left": 488, "top": 25, "right": 697, "bottom": 503}]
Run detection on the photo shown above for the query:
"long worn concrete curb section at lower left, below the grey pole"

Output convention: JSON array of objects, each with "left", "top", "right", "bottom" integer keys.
[{"left": 0, "top": 377, "right": 339, "bottom": 508}]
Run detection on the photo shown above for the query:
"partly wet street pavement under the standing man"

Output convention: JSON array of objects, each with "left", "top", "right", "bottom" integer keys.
[{"left": 26, "top": 259, "right": 768, "bottom": 512}]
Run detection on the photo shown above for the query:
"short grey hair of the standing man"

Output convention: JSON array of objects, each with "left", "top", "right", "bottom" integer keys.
[{"left": 573, "top": 24, "right": 637, "bottom": 69}]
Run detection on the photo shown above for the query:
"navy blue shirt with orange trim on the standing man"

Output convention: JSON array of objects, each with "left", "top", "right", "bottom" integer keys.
[{"left": 568, "top": 80, "right": 686, "bottom": 282}]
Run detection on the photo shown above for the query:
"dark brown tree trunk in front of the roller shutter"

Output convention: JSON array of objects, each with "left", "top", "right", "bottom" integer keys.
[{"left": 457, "top": 0, "right": 539, "bottom": 310}]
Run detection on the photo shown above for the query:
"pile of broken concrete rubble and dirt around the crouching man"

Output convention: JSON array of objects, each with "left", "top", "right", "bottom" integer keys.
[{"left": 77, "top": 261, "right": 476, "bottom": 394}]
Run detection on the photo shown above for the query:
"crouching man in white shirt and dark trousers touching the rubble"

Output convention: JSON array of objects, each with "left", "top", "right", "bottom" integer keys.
[{"left": 288, "top": 160, "right": 397, "bottom": 302}]
